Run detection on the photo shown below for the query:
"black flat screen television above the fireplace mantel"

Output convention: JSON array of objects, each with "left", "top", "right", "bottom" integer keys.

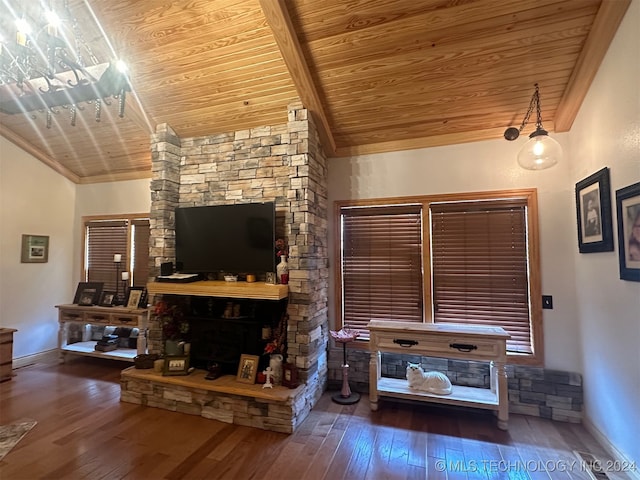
[{"left": 175, "top": 202, "right": 275, "bottom": 274}]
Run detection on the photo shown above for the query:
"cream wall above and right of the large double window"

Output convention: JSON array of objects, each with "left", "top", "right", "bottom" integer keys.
[{"left": 329, "top": 128, "right": 582, "bottom": 372}]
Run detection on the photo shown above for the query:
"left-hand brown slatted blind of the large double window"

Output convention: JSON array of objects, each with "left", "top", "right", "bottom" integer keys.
[{"left": 341, "top": 205, "right": 423, "bottom": 339}]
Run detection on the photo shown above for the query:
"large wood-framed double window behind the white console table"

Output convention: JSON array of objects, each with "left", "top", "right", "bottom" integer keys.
[{"left": 336, "top": 190, "right": 542, "bottom": 364}]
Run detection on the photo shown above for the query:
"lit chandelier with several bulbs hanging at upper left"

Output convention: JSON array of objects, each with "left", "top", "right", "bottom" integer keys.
[{"left": 0, "top": 0, "right": 131, "bottom": 128}]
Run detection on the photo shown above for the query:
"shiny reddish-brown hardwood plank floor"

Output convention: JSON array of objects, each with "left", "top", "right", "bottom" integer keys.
[{"left": 0, "top": 357, "right": 631, "bottom": 480}]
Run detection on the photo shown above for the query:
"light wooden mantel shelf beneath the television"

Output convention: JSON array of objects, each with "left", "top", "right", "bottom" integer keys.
[{"left": 147, "top": 280, "right": 289, "bottom": 300}]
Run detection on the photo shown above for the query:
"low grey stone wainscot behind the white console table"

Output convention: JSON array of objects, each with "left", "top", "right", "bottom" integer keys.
[{"left": 336, "top": 349, "right": 583, "bottom": 423}]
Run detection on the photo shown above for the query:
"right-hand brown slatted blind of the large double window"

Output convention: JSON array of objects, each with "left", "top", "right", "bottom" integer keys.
[{"left": 430, "top": 199, "right": 533, "bottom": 353}]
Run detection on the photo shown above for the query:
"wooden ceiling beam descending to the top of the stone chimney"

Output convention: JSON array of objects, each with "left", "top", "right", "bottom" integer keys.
[{"left": 260, "top": 0, "right": 336, "bottom": 156}]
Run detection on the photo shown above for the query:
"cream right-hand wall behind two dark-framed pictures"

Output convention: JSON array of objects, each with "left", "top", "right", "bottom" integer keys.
[{"left": 570, "top": 0, "right": 640, "bottom": 465}]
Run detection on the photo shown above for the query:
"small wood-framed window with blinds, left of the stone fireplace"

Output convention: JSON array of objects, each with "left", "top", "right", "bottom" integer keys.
[{"left": 83, "top": 215, "right": 150, "bottom": 290}]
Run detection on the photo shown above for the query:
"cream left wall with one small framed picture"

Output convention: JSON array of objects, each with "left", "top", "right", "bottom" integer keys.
[{"left": 0, "top": 137, "right": 76, "bottom": 358}]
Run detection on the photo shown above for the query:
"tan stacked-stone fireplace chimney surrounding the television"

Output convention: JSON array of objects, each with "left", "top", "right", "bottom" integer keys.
[{"left": 148, "top": 102, "right": 329, "bottom": 406}]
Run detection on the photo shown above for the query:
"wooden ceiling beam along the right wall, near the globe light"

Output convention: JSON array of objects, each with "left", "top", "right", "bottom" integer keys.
[{"left": 554, "top": 0, "right": 631, "bottom": 132}]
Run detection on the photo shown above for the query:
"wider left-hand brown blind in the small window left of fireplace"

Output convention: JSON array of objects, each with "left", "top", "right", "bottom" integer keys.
[{"left": 85, "top": 220, "right": 128, "bottom": 291}]
